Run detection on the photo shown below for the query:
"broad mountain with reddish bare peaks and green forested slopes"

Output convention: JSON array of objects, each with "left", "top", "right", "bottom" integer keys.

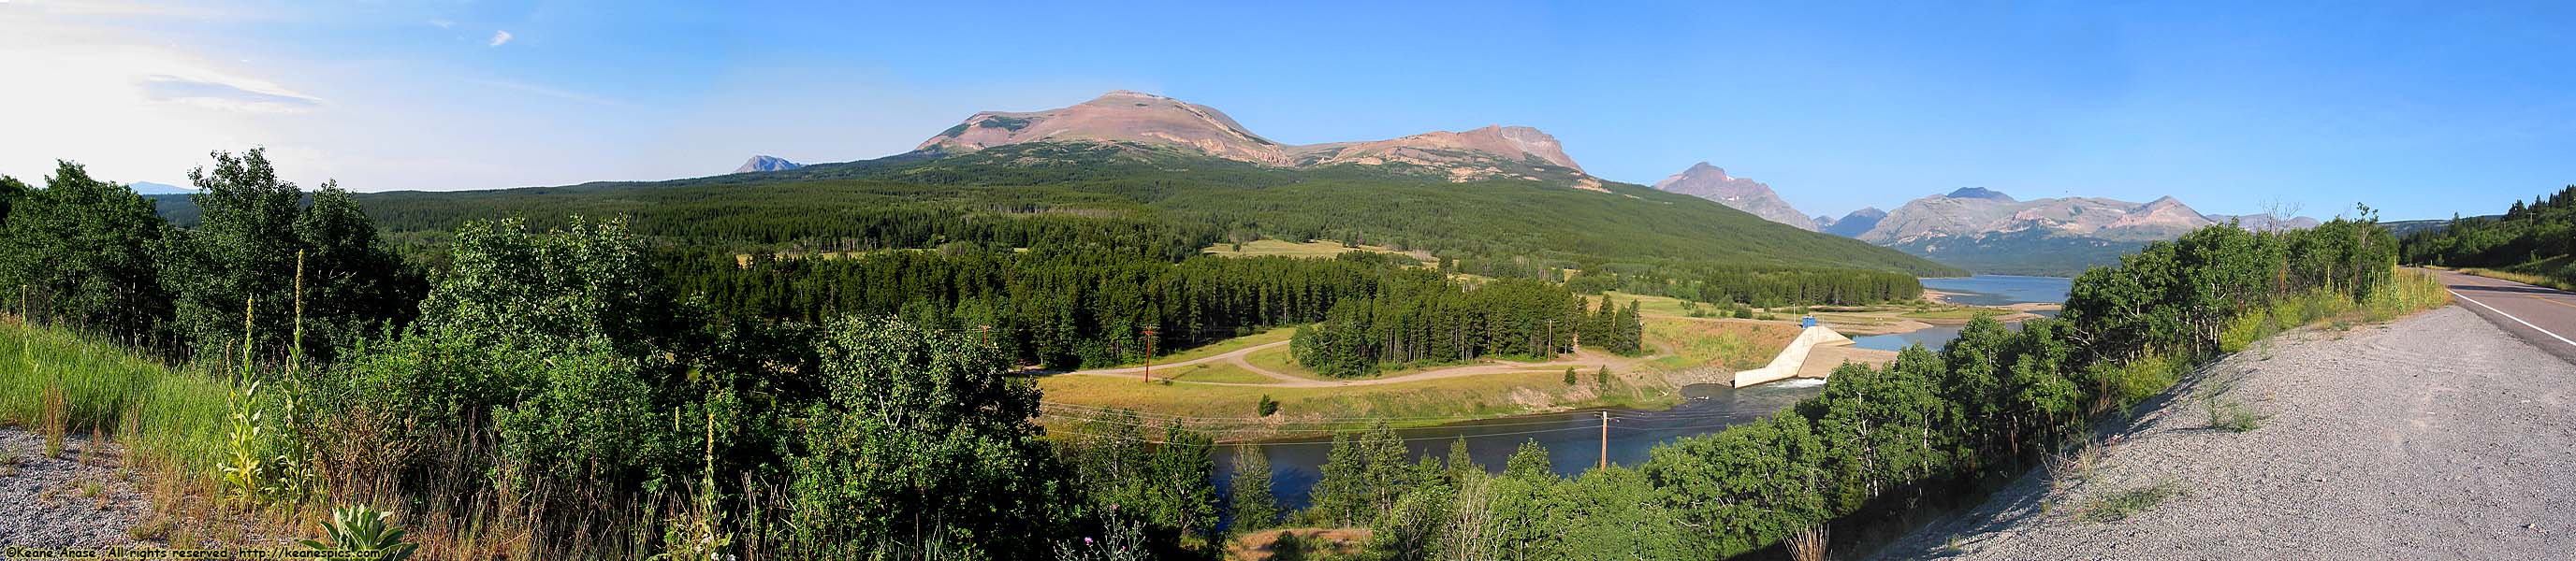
[{"left": 200, "top": 93, "right": 1966, "bottom": 283}]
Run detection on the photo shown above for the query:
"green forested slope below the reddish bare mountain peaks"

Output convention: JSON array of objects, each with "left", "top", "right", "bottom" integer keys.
[{"left": 146, "top": 144, "right": 1957, "bottom": 275}]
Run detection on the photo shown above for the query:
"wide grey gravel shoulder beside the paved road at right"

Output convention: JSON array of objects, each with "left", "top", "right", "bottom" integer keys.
[{"left": 1881, "top": 307, "right": 2576, "bottom": 558}]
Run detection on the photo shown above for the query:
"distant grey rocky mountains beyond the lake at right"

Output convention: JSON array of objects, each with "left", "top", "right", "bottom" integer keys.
[{"left": 1653, "top": 162, "right": 2319, "bottom": 275}]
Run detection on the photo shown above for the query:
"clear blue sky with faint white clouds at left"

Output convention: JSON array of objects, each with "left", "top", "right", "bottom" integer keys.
[{"left": 0, "top": 0, "right": 2576, "bottom": 219}]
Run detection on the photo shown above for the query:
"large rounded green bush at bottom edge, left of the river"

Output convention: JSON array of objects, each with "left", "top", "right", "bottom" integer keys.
[{"left": 788, "top": 319, "right": 1071, "bottom": 558}]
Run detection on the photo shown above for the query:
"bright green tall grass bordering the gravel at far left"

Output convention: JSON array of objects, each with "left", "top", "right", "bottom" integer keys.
[{"left": 0, "top": 319, "right": 232, "bottom": 476}]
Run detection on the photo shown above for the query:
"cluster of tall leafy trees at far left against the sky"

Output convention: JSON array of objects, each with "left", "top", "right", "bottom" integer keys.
[{"left": 0, "top": 150, "right": 425, "bottom": 360}]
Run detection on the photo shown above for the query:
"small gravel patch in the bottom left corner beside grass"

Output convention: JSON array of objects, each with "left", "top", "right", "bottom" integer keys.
[{"left": 0, "top": 427, "right": 152, "bottom": 548}]
